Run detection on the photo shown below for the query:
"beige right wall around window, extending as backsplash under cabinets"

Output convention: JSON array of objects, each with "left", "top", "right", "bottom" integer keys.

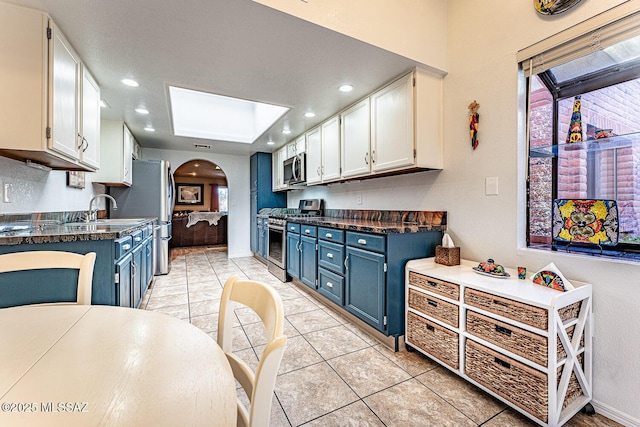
[{"left": 288, "top": 0, "right": 640, "bottom": 425}]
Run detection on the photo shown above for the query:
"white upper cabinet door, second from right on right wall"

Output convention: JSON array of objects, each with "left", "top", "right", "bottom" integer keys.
[{"left": 340, "top": 98, "right": 371, "bottom": 178}]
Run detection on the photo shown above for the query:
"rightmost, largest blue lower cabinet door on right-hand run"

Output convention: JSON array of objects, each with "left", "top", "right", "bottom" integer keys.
[{"left": 345, "top": 246, "right": 386, "bottom": 331}]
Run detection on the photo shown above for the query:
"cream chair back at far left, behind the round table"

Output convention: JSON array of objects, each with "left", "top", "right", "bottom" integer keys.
[{"left": 0, "top": 251, "right": 96, "bottom": 305}]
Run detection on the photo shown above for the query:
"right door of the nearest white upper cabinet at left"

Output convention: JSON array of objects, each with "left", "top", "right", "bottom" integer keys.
[{"left": 80, "top": 65, "right": 100, "bottom": 169}]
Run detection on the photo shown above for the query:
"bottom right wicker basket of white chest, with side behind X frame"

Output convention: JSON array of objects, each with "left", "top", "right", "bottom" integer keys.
[{"left": 465, "top": 339, "right": 583, "bottom": 422}]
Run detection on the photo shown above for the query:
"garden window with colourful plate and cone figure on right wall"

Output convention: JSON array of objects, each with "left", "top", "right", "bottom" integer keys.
[{"left": 519, "top": 15, "right": 640, "bottom": 260}]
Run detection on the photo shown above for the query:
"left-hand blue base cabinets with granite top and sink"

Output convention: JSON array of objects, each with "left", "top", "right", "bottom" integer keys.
[{"left": 0, "top": 215, "right": 156, "bottom": 308}]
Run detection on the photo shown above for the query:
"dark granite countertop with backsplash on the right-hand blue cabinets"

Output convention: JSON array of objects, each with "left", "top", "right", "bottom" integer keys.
[{"left": 288, "top": 210, "right": 447, "bottom": 234}]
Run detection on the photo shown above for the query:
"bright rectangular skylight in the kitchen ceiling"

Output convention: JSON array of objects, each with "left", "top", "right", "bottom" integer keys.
[{"left": 169, "top": 86, "right": 289, "bottom": 144}]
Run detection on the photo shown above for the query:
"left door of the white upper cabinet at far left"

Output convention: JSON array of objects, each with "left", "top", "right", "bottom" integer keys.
[{"left": 49, "top": 22, "right": 82, "bottom": 160}]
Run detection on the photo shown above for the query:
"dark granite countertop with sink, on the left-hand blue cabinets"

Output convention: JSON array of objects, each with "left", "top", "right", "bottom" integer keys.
[{"left": 0, "top": 218, "right": 156, "bottom": 245}]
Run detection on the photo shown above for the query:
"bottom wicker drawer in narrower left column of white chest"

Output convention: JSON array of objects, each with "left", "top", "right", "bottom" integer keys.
[{"left": 407, "top": 312, "right": 459, "bottom": 369}]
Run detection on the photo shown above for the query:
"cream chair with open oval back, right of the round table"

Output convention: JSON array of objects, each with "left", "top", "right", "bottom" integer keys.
[{"left": 218, "top": 276, "right": 287, "bottom": 427}]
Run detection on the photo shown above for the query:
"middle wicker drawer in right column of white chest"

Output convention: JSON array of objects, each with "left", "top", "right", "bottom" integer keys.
[{"left": 467, "top": 310, "right": 548, "bottom": 366}]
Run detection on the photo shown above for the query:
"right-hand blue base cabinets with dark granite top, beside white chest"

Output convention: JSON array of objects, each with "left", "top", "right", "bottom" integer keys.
[{"left": 286, "top": 210, "right": 447, "bottom": 351}]
